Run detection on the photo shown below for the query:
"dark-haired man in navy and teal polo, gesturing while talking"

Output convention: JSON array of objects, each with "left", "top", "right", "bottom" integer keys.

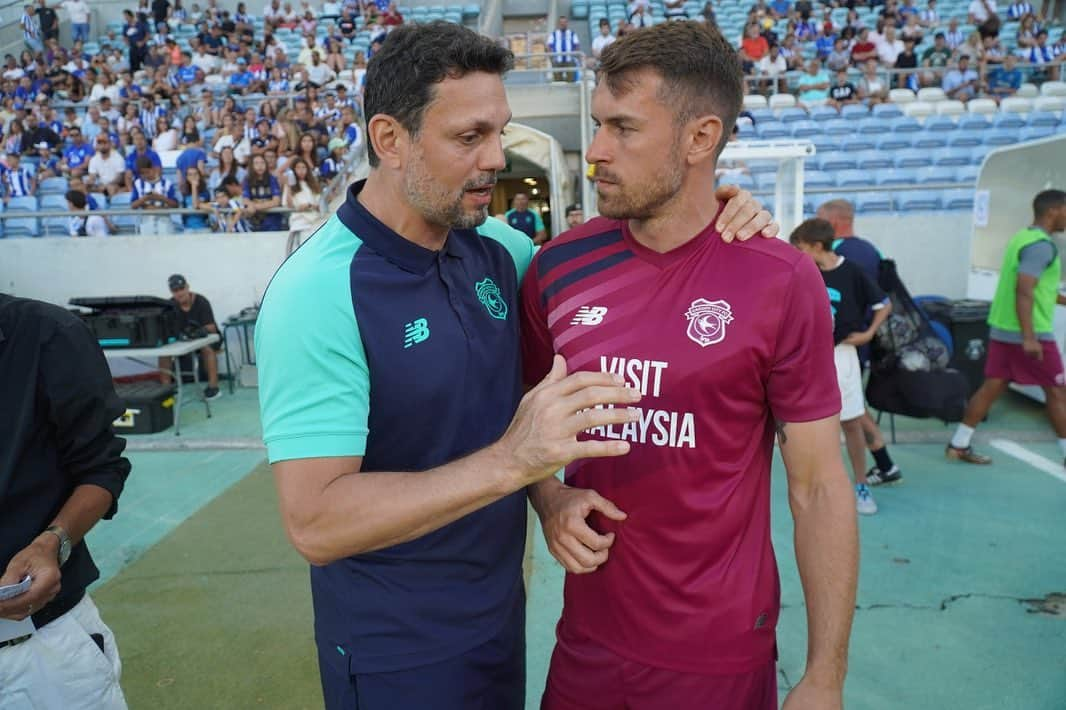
[{"left": 256, "top": 22, "right": 769, "bottom": 710}]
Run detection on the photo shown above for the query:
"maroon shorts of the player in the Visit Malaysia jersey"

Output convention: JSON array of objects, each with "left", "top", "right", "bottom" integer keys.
[{"left": 540, "top": 632, "right": 777, "bottom": 710}]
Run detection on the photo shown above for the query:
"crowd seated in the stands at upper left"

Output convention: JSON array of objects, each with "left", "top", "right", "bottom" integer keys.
[{"left": 0, "top": 0, "right": 379, "bottom": 235}]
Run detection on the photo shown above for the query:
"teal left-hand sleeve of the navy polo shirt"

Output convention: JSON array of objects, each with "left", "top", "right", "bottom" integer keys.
[{"left": 255, "top": 216, "right": 370, "bottom": 464}]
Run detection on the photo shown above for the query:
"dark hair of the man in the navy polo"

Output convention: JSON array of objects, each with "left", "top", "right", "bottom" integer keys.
[{"left": 362, "top": 20, "right": 515, "bottom": 166}]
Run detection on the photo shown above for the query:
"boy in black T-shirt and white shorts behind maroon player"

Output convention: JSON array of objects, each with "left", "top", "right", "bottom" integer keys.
[{"left": 789, "top": 220, "right": 892, "bottom": 515}]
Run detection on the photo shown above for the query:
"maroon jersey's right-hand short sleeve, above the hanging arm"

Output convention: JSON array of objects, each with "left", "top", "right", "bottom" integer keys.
[{"left": 766, "top": 259, "right": 840, "bottom": 422}]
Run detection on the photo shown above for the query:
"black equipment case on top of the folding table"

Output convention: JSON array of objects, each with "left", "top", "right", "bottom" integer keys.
[{"left": 70, "top": 296, "right": 178, "bottom": 348}]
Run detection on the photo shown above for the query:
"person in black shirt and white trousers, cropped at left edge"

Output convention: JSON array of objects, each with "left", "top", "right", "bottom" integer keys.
[{"left": 0, "top": 294, "right": 130, "bottom": 710}]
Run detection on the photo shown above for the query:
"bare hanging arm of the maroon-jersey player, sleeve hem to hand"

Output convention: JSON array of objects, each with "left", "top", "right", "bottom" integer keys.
[{"left": 777, "top": 416, "right": 858, "bottom": 710}]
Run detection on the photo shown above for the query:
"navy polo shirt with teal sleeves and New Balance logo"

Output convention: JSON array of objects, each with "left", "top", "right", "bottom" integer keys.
[{"left": 256, "top": 182, "right": 534, "bottom": 673}]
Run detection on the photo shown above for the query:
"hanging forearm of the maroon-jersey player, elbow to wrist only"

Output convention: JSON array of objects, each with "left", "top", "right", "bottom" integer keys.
[{"left": 789, "top": 464, "right": 858, "bottom": 688}]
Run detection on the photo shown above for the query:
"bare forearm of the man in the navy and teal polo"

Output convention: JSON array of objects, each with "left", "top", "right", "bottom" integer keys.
[{"left": 286, "top": 446, "right": 522, "bottom": 565}]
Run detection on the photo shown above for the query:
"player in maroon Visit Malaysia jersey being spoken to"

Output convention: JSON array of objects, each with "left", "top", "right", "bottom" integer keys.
[{"left": 522, "top": 21, "right": 858, "bottom": 710}]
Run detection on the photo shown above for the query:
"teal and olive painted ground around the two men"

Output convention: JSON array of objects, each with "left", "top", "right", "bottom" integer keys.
[{"left": 91, "top": 390, "right": 1066, "bottom": 710}]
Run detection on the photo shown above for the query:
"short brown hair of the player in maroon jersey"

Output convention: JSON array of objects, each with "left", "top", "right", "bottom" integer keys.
[{"left": 600, "top": 20, "right": 744, "bottom": 151}]
